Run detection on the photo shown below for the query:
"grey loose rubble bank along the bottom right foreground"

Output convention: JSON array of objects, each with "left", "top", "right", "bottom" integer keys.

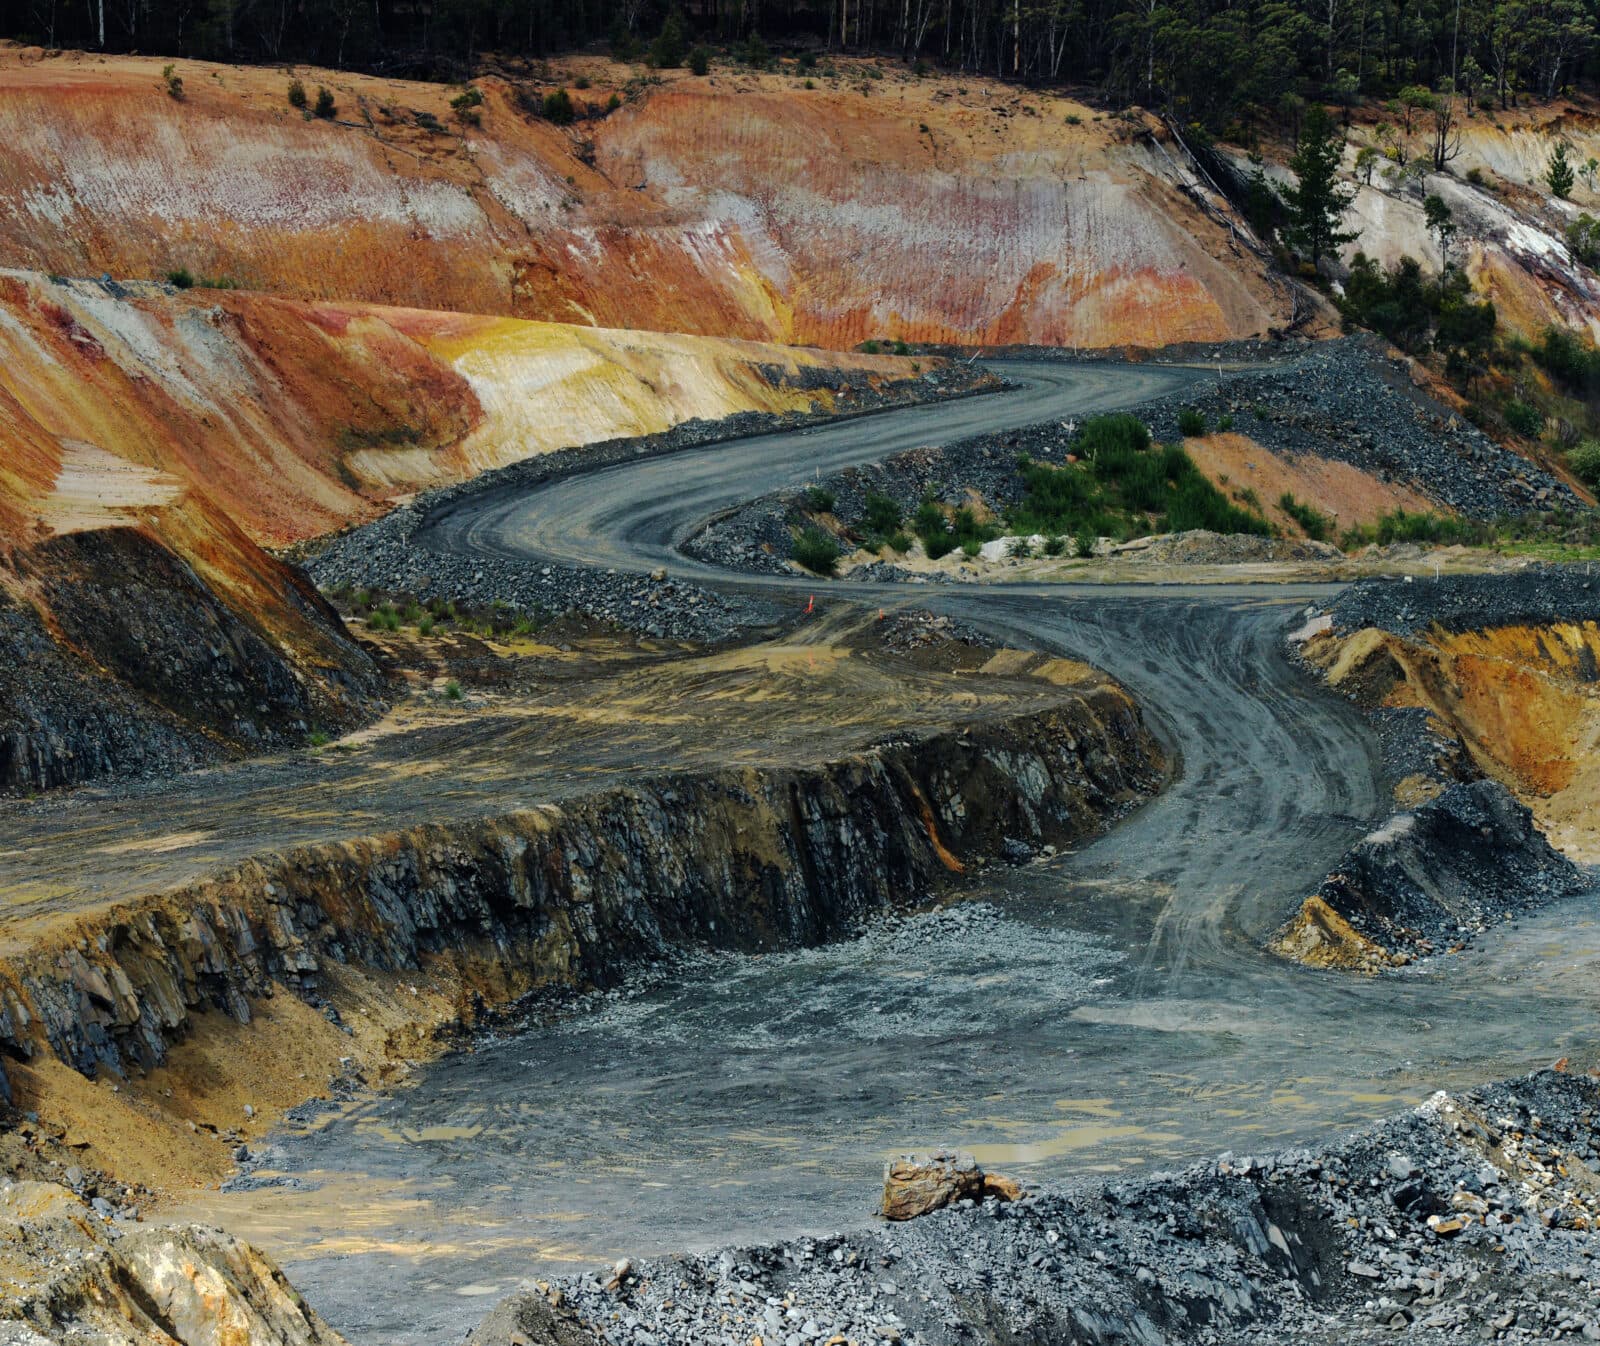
[{"left": 489, "top": 1071, "right": 1600, "bottom": 1346}]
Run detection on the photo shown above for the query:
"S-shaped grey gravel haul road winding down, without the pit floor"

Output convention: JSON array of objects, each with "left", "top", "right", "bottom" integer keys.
[{"left": 416, "top": 362, "right": 1382, "bottom": 970}]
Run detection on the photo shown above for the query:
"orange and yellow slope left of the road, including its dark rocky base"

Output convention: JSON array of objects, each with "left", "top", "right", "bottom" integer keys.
[{"left": 0, "top": 264, "right": 939, "bottom": 789}]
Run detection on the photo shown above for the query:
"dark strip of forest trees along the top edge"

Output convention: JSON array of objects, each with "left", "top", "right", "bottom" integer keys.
[{"left": 12, "top": 0, "right": 1597, "bottom": 131}]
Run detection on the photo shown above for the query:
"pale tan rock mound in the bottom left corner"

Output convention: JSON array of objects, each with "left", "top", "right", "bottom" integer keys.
[{"left": 0, "top": 1183, "right": 344, "bottom": 1346}]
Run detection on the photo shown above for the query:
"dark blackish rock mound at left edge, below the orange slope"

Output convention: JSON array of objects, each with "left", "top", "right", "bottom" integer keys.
[{"left": 0, "top": 528, "right": 387, "bottom": 794}]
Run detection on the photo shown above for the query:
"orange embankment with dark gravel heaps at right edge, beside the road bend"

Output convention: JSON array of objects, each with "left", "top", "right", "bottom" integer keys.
[{"left": 1278, "top": 567, "right": 1600, "bottom": 968}]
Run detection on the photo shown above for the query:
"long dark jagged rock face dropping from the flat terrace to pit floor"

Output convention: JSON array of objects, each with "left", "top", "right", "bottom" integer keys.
[{"left": 0, "top": 685, "right": 1162, "bottom": 1094}]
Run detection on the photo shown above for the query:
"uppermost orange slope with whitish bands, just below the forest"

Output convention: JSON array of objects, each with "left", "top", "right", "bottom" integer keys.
[{"left": 0, "top": 50, "right": 1290, "bottom": 347}]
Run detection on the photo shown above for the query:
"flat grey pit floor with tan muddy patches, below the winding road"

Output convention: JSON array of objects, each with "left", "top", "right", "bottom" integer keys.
[{"left": 175, "top": 848, "right": 1600, "bottom": 1346}]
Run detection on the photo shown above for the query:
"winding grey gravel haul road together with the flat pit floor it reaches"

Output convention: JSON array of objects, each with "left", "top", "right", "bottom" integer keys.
[{"left": 175, "top": 365, "right": 1600, "bottom": 1346}]
